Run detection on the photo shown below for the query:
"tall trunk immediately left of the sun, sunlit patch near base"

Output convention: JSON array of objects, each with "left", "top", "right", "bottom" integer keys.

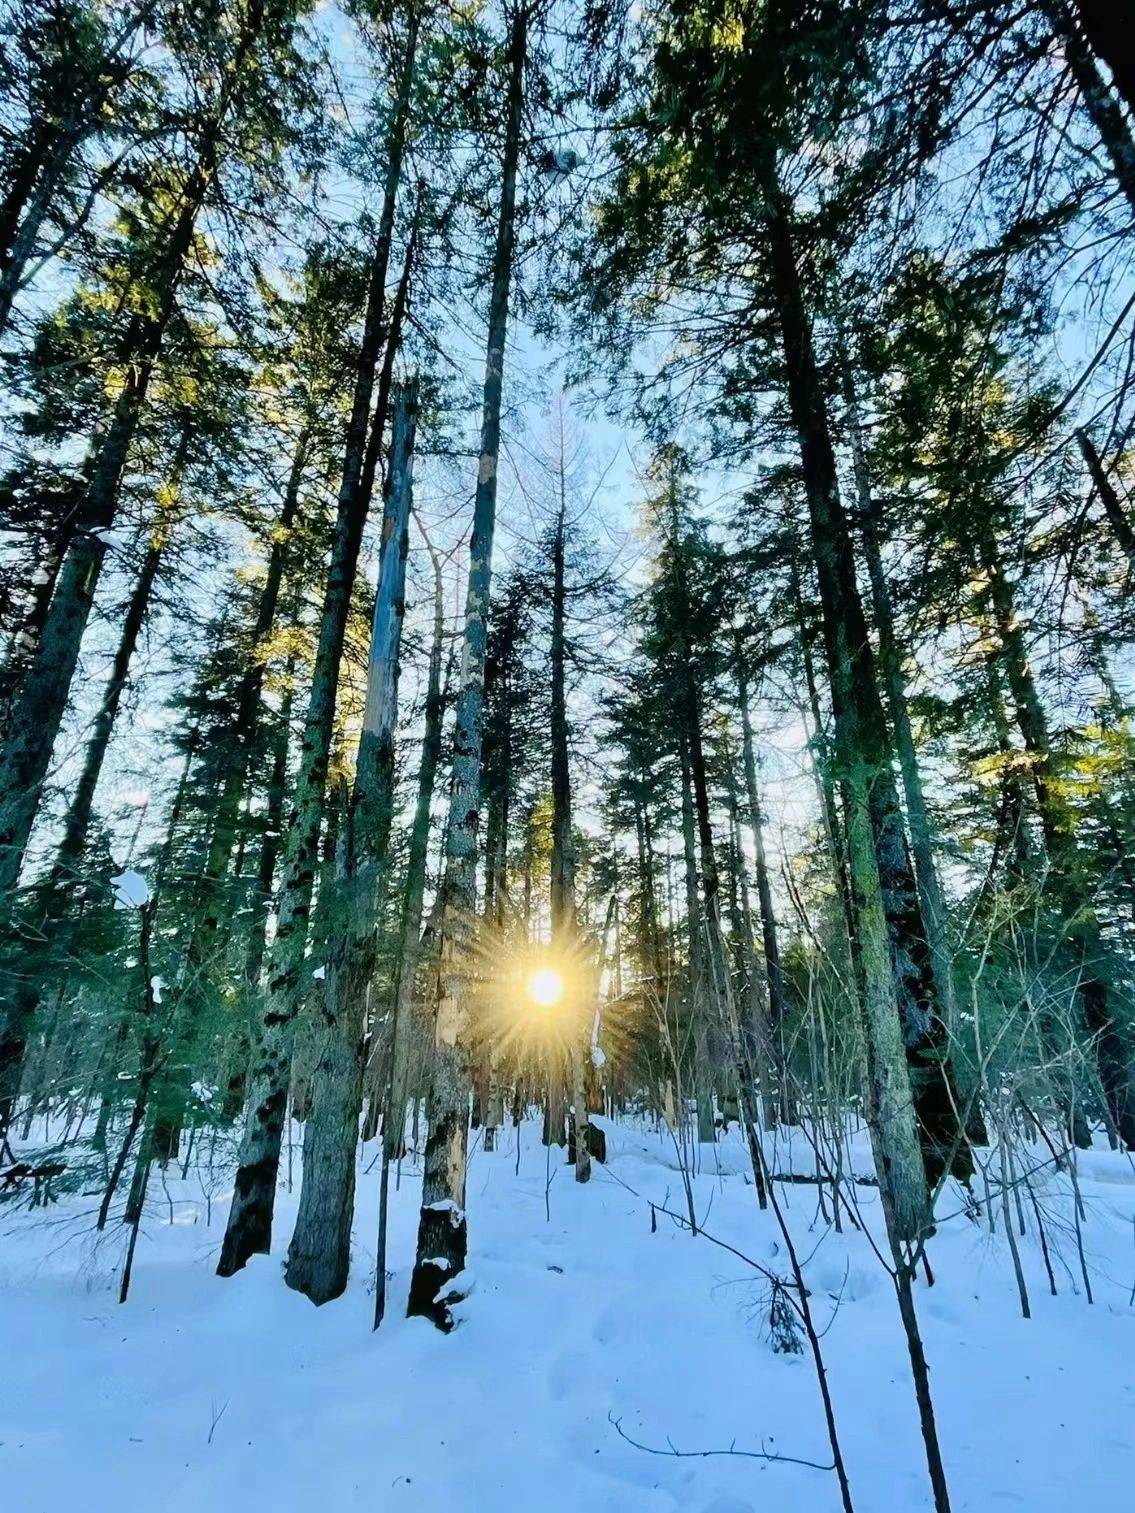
[{"left": 407, "top": 0, "right": 528, "bottom": 1330}]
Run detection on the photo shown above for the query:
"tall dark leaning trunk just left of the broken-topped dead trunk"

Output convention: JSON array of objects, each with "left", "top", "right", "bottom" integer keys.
[{"left": 216, "top": 12, "right": 418, "bottom": 1277}]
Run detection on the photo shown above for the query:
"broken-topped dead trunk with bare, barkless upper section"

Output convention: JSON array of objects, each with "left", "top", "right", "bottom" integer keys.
[{"left": 285, "top": 383, "right": 418, "bottom": 1303}]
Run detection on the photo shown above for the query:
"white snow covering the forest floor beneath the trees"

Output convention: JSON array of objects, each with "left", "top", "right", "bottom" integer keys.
[{"left": 0, "top": 1124, "right": 1135, "bottom": 1513}]
